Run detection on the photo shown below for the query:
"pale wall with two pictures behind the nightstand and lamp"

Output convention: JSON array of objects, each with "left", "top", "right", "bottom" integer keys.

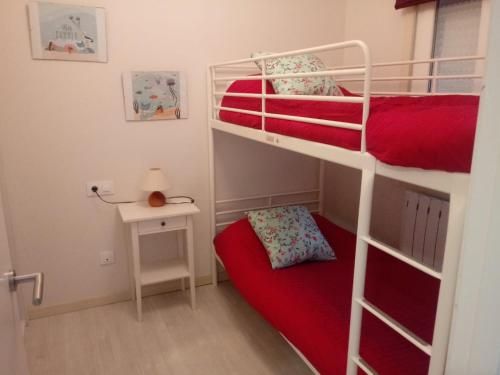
[{"left": 0, "top": 0, "right": 345, "bottom": 312}]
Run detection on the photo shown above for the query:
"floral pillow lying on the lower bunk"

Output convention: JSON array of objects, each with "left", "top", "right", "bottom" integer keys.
[{"left": 248, "top": 206, "right": 335, "bottom": 269}]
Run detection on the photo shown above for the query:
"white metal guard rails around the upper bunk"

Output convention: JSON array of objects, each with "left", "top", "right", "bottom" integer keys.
[{"left": 208, "top": 40, "right": 485, "bottom": 152}]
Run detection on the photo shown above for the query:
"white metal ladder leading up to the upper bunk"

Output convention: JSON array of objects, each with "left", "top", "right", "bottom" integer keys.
[{"left": 347, "top": 168, "right": 469, "bottom": 375}]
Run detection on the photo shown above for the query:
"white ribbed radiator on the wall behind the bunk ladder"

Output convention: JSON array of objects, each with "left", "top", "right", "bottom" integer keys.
[{"left": 400, "top": 191, "right": 449, "bottom": 270}]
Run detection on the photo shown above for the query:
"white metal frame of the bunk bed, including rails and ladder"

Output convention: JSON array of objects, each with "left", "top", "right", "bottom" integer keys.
[{"left": 207, "top": 40, "right": 484, "bottom": 375}]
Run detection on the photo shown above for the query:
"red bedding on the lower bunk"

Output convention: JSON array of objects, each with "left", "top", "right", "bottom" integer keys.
[{"left": 214, "top": 215, "right": 439, "bottom": 374}]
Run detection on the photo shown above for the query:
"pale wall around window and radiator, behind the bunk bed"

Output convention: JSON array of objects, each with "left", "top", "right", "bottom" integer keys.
[{"left": 325, "top": 0, "right": 416, "bottom": 235}]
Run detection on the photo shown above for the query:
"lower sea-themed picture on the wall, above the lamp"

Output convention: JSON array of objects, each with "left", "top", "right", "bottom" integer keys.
[{"left": 123, "top": 71, "right": 188, "bottom": 121}]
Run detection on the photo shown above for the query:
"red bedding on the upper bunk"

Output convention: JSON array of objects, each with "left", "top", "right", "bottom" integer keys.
[{"left": 220, "top": 80, "right": 479, "bottom": 172}]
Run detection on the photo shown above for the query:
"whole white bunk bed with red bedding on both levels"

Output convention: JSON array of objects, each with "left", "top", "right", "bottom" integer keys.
[{"left": 208, "top": 41, "right": 482, "bottom": 374}]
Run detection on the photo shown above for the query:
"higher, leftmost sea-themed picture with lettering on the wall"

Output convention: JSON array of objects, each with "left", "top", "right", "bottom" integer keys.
[{"left": 28, "top": 2, "right": 108, "bottom": 62}]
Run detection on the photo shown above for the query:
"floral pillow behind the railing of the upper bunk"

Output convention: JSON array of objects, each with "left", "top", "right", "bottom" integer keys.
[{"left": 251, "top": 52, "right": 342, "bottom": 96}]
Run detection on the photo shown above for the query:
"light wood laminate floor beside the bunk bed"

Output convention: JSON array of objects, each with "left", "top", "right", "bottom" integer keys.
[{"left": 26, "top": 282, "right": 311, "bottom": 375}]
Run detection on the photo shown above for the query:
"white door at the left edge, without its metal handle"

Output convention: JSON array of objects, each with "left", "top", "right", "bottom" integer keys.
[{"left": 0, "top": 189, "right": 28, "bottom": 375}]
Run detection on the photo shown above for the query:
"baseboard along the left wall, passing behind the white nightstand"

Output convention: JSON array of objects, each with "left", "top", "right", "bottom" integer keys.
[{"left": 28, "top": 272, "right": 227, "bottom": 320}]
